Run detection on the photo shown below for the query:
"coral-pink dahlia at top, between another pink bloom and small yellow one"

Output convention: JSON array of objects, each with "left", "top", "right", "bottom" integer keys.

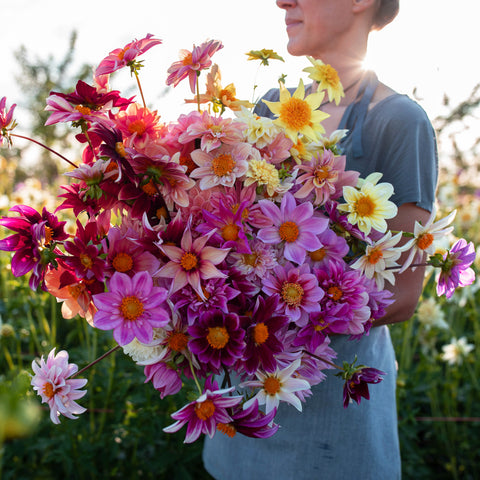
[{"left": 167, "top": 40, "right": 223, "bottom": 93}]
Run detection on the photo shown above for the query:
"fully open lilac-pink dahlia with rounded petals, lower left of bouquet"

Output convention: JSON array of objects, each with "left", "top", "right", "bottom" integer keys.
[{"left": 93, "top": 272, "right": 170, "bottom": 346}]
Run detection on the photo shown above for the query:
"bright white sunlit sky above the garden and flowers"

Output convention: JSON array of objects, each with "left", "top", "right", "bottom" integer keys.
[{"left": 0, "top": 0, "right": 480, "bottom": 125}]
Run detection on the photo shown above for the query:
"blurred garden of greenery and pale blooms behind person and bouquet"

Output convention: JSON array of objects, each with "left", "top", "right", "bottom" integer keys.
[{"left": 0, "top": 2, "right": 480, "bottom": 480}]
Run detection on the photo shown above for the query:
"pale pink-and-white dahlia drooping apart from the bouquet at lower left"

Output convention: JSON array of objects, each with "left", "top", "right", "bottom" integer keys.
[{"left": 31, "top": 349, "right": 87, "bottom": 424}]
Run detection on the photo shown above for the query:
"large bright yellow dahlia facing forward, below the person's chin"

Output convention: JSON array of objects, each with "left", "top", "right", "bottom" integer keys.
[{"left": 263, "top": 80, "right": 330, "bottom": 143}]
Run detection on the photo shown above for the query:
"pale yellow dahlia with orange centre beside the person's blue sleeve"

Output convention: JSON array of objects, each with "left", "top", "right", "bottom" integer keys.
[{"left": 338, "top": 173, "right": 398, "bottom": 235}]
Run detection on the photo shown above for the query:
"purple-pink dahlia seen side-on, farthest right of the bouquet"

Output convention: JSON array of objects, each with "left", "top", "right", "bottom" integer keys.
[{"left": 437, "top": 238, "right": 475, "bottom": 298}]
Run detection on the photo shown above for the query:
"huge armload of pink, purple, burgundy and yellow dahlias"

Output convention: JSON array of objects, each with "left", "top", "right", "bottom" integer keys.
[{"left": 0, "top": 35, "right": 474, "bottom": 442}]
